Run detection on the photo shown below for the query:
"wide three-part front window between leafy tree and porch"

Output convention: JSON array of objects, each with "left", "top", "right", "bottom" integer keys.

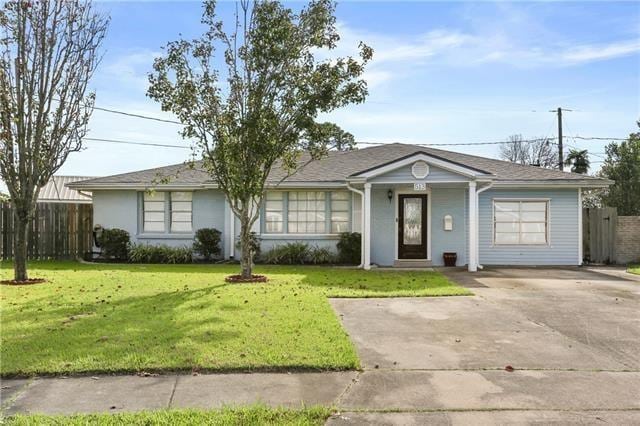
[{"left": 264, "top": 191, "right": 351, "bottom": 234}]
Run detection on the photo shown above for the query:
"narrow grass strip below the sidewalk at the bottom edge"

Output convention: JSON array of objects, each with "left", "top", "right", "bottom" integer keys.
[{"left": 7, "top": 406, "right": 331, "bottom": 426}]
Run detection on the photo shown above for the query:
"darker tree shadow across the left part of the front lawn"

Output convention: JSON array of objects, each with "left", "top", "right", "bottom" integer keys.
[{"left": 2, "top": 286, "right": 241, "bottom": 376}]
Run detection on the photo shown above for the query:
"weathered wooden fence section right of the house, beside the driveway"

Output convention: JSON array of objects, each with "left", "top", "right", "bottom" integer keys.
[{"left": 582, "top": 207, "right": 618, "bottom": 263}]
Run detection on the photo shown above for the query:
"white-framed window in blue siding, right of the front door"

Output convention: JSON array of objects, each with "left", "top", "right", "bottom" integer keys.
[{"left": 493, "top": 200, "right": 549, "bottom": 245}]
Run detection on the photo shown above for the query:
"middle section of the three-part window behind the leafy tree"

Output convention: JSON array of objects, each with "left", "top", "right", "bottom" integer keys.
[{"left": 287, "top": 191, "right": 327, "bottom": 234}]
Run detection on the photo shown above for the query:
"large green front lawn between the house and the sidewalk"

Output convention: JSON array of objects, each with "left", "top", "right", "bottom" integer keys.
[{"left": 0, "top": 262, "right": 469, "bottom": 377}]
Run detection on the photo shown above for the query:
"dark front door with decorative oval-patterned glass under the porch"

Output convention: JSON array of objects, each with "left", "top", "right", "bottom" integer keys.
[{"left": 398, "top": 194, "right": 427, "bottom": 259}]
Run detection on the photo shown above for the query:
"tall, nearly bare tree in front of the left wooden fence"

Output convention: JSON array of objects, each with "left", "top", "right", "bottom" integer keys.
[{"left": 0, "top": 0, "right": 109, "bottom": 281}]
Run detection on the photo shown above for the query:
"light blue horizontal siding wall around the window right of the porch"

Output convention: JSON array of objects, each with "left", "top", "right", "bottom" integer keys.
[{"left": 478, "top": 189, "right": 581, "bottom": 265}]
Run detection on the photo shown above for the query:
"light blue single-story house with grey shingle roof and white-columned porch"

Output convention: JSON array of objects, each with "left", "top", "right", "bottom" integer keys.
[{"left": 69, "top": 144, "right": 611, "bottom": 271}]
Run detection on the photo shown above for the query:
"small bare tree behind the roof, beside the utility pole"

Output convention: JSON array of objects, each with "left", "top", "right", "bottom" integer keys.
[{"left": 499, "top": 135, "right": 558, "bottom": 169}]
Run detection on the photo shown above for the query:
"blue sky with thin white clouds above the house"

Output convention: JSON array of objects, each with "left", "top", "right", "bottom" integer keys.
[{"left": 53, "top": 2, "right": 640, "bottom": 176}]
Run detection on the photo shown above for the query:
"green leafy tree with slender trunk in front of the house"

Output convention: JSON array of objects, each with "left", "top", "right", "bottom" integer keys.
[{"left": 148, "top": 0, "right": 373, "bottom": 278}]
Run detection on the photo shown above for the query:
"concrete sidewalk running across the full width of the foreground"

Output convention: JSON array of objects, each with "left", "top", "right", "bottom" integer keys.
[{"left": 2, "top": 370, "right": 640, "bottom": 416}]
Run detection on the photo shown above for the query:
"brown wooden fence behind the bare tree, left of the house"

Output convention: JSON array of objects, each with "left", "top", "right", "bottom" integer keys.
[{"left": 0, "top": 202, "right": 93, "bottom": 260}]
